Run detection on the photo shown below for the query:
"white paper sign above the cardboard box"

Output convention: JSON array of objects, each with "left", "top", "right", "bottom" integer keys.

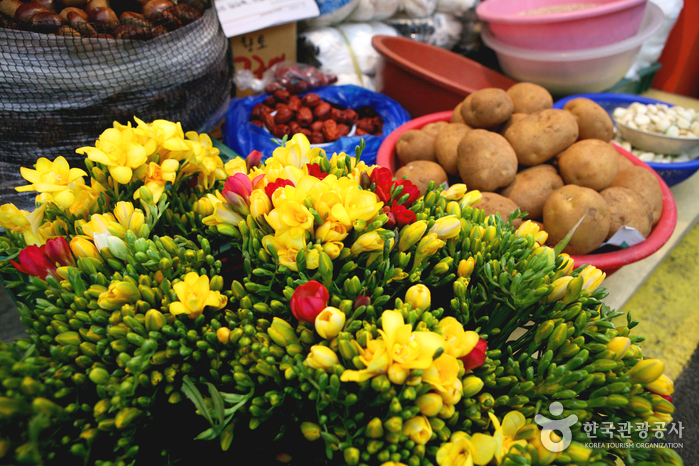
[{"left": 214, "top": 0, "right": 320, "bottom": 37}]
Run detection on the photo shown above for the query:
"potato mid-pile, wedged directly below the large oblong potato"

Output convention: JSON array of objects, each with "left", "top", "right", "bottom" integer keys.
[{"left": 500, "top": 165, "right": 563, "bottom": 219}]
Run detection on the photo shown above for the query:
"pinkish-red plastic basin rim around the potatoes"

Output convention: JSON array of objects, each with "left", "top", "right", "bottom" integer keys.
[{"left": 376, "top": 111, "right": 677, "bottom": 275}]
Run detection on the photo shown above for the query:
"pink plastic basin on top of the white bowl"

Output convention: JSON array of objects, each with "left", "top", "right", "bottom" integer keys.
[{"left": 476, "top": 0, "right": 648, "bottom": 50}]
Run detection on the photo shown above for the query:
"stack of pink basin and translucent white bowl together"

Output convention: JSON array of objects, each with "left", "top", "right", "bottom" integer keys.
[{"left": 476, "top": 0, "right": 664, "bottom": 96}]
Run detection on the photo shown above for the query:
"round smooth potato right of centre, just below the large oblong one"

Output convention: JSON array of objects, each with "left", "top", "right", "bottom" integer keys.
[{"left": 558, "top": 139, "right": 619, "bottom": 191}]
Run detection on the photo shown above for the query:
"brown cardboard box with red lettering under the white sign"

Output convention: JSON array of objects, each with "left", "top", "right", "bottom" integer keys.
[{"left": 230, "top": 22, "right": 296, "bottom": 97}]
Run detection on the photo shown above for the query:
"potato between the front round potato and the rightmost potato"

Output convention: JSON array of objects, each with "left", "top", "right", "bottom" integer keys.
[{"left": 600, "top": 186, "right": 653, "bottom": 239}]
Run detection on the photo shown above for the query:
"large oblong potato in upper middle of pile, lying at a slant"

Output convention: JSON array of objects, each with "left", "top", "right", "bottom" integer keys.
[{"left": 505, "top": 109, "right": 578, "bottom": 167}]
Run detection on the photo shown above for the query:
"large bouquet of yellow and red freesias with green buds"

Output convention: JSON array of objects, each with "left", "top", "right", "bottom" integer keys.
[{"left": 0, "top": 120, "right": 681, "bottom": 466}]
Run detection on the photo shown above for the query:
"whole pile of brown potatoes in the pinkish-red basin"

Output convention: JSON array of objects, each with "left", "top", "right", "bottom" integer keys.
[{"left": 396, "top": 83, "right": 663, "bottom": 254}]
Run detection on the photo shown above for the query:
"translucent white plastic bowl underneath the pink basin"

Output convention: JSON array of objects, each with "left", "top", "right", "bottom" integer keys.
[{"left": 481, "top": 3, "right": 664, "bottom": 95}]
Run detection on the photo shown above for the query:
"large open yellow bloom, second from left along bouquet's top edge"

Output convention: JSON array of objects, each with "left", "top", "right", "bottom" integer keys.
[{"left": 75, "top": 127, "right": 150, "bottom": 184}]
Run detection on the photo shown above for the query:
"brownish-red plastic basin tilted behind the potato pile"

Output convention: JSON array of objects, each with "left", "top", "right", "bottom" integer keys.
[{"left": 371, "top": 36, "right": 516, "bottom": 118}]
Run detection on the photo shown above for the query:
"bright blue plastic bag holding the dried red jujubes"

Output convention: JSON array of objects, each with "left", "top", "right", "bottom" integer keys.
[{"left": 223, "top": 85, "right": 410, "bottom": 165}]
